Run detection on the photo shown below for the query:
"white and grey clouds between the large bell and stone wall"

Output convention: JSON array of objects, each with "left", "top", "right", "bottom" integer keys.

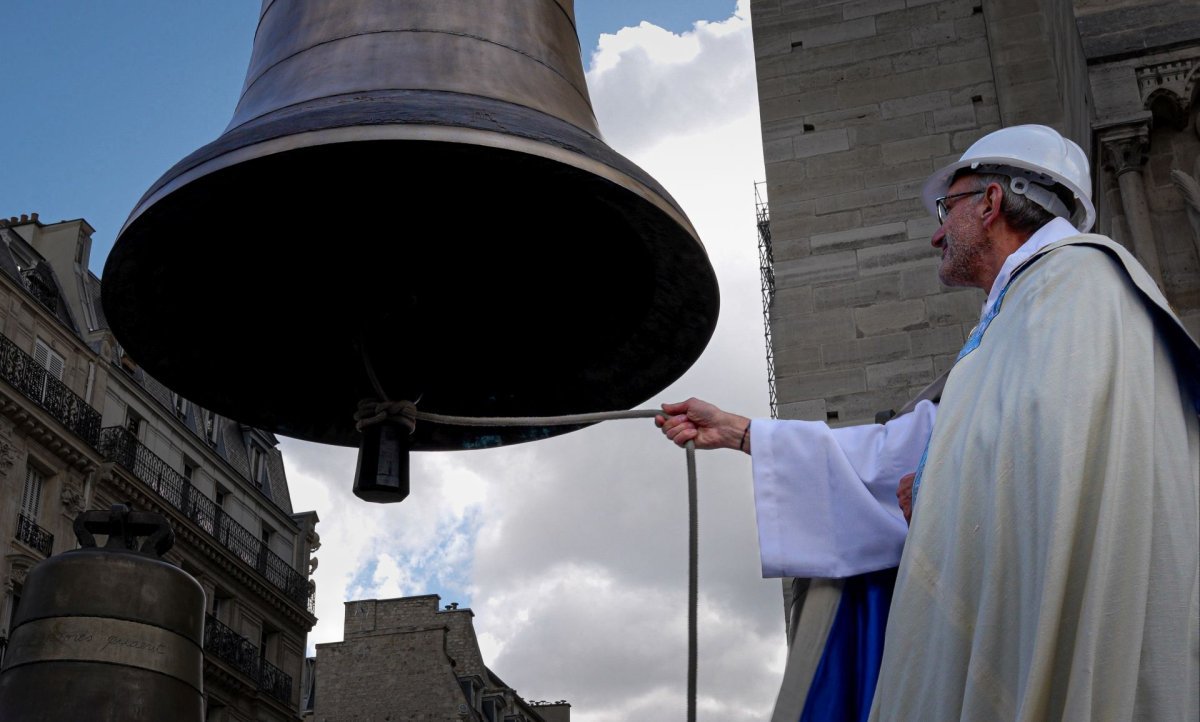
[{"left": 284, "top": 0, "right": 785, "bottom": 722}]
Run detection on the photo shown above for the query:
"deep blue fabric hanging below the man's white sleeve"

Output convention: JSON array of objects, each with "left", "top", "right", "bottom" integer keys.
[{"left": 799, "top": 568, "right": 896, "bottom": 722}]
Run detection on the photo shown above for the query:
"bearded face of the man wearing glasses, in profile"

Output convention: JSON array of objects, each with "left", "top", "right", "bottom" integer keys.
[{"left": 932, "top": 176, "right": 994, "bottom": 291}]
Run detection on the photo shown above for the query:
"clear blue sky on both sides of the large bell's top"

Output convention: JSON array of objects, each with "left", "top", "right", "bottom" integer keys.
[{"left": 0, "top": 0, "right": 736, "bottom": 275}]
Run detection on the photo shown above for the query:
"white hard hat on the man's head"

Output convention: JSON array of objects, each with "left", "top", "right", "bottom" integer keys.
[{"left": 920, "top": 125, "right": 1096, "bottom": 233}]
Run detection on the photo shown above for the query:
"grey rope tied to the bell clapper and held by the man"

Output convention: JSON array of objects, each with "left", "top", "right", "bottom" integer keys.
[{"left": 354, "top": 395, "right": 700, "bottom": 722}]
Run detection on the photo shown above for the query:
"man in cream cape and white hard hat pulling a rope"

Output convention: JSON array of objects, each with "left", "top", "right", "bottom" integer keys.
[{"left": 660, "top": 126, "right": 1200, "bottom": 722}]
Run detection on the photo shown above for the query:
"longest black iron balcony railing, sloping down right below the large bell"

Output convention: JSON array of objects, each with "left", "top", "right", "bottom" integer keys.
[{"left": 98, "top": 426, "right": 314, "bottom": 614}]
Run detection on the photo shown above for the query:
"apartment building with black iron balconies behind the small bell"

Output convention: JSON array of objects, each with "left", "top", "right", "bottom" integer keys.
[{"left": 0, "top": 213, "right": 319, "bottom": 722}]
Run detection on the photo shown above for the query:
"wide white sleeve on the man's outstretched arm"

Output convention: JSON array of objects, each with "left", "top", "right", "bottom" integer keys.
[{"left": 750, "top": 401, "right": 937, "bottom": 577}]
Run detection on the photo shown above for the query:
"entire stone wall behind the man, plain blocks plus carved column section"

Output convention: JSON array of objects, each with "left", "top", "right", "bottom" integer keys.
[{"left": 751, "top": 0, "right": 1200, "bottom": 425}]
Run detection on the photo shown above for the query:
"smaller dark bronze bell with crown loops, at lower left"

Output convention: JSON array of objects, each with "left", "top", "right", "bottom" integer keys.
[{"left": 0, "top": 505, "right": 204, "bottom": 722}]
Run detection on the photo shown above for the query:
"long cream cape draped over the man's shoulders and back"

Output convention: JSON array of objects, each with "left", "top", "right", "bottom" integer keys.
[{"left": 873, "top": 236, "right": 1200, "bottom": 722}]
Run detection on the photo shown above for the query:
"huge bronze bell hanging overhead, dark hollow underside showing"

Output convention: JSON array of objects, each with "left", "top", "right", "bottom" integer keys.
[{"left": 103, "top": 0, "right": 719, "bottom": 450}]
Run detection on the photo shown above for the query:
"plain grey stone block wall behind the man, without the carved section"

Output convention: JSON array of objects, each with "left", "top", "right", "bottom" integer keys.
[{"left": 750, "top": 0, "right": 1086, "bottom": 425}]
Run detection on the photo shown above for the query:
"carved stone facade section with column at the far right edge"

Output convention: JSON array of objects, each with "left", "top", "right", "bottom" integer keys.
[{"left": 1076, "top": 0, "right": 1200, "bottom": 336}]
